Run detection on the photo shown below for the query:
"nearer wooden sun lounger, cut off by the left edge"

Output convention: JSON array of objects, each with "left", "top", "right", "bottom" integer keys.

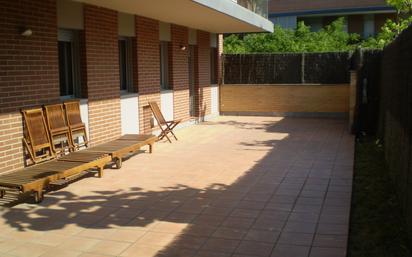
[{"left": 0, "top": 153, "right": 111, "bottom": 203}]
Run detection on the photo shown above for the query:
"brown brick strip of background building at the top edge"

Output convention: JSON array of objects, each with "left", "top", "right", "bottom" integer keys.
[{"left": 269, "top": 0, "right": 386, "bottom": 13}]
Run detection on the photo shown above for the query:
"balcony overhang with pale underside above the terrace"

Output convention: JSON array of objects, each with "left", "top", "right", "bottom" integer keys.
[{"left": 75, "top": 0, "right": 273, "bottom": 33}]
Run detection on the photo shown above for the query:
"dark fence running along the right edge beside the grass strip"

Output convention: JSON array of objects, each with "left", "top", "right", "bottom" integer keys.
[{"left": 379, "top": 27, "right": 412, "bottom": 238}]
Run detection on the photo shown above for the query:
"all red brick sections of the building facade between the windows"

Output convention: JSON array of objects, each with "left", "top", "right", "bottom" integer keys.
[{"left": 0, "top": 0, "right": 221, "bottom": 173}]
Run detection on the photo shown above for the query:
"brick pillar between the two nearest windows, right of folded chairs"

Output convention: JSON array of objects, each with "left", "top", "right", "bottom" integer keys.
[{"left": 84, "top": 5, "right": 121, "bottom": 145}]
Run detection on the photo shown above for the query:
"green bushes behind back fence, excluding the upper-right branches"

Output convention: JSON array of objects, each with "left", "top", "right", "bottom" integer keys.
[{"left": 224, "top": 18, "right": 359, "bottom": 54}]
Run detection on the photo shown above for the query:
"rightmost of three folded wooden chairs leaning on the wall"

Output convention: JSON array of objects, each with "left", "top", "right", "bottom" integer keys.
[{"left": 64, "top": 101, "right": 89, "bottom": 150}]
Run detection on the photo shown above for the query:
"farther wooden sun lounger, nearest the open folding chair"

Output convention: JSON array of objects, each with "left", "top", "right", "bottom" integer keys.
[{"left": 85, "top": 134, "right": 158, "bottom": 169}]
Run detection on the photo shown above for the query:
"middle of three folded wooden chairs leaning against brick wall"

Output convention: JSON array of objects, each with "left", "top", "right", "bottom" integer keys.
[{"left": 44, "top": 104, "right": 74, "bottom": 155}]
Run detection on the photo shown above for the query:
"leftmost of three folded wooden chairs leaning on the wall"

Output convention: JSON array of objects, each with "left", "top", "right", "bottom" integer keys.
[{"left": 22, "top": 108, "right": 55, "bottom": 163}]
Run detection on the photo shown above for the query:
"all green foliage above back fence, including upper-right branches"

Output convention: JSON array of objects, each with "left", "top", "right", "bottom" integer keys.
[{"left": 224, "top": 0, "right": 412, "bottom": 54}]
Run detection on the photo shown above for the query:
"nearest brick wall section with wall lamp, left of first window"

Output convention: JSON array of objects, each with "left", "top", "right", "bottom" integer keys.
[{"left": 0, "top": 0, "right": 59, "bottom": 172}]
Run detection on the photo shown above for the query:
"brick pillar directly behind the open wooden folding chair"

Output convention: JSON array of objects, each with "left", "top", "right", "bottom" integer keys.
[{"left": 135, "top": 16, "right": 160, "bottom": 133}]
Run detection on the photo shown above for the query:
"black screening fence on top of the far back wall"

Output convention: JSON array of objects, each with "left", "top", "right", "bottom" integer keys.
[{"left": 223, "top": 52, "right": 352, "bottom": 84}]
